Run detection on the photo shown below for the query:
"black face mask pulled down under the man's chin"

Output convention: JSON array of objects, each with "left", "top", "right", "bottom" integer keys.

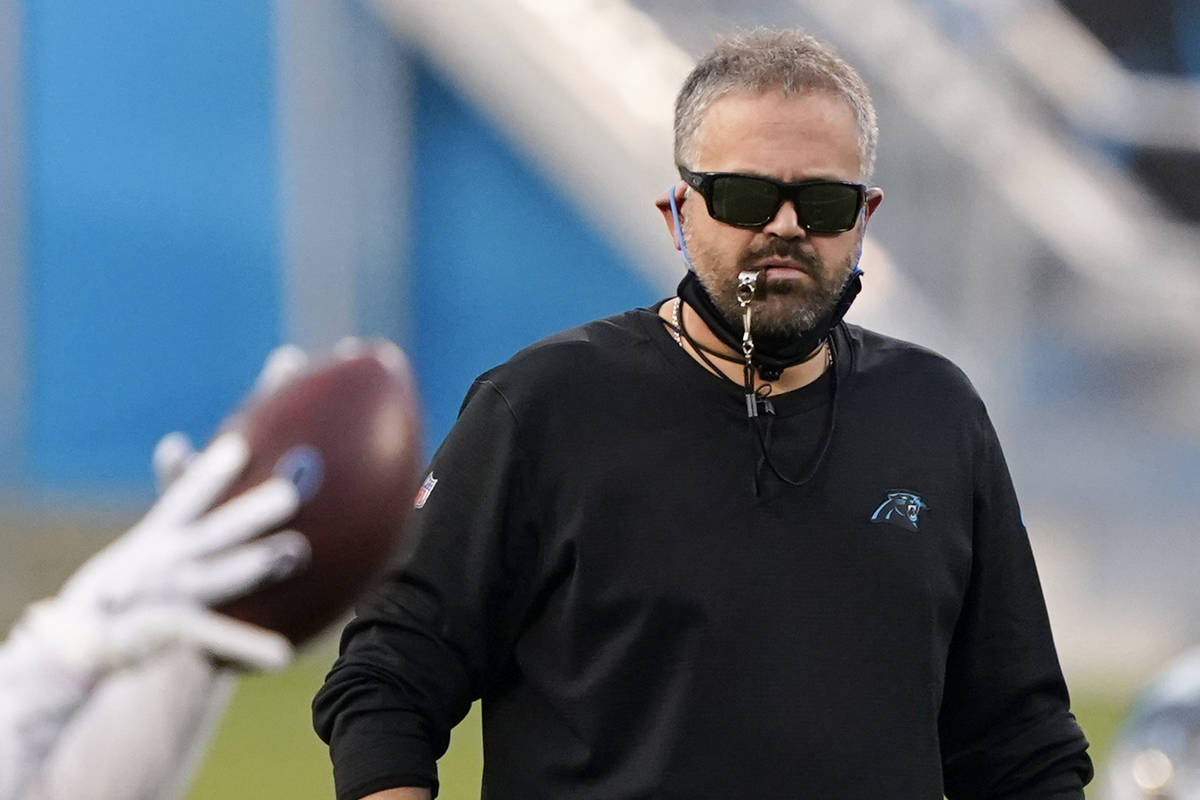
[{"left": 676, "top": 269, "right": 863, "bottom": 380}]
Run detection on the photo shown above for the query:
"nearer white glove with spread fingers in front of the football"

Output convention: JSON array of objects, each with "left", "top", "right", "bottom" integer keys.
[{"left": 19, "top": 434, "right": 310, "bottom": 681}]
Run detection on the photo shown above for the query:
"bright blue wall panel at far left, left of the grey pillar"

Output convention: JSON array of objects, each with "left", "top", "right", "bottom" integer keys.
[{"left": 25, "top": 0, "right": 280, "bottom": 487}]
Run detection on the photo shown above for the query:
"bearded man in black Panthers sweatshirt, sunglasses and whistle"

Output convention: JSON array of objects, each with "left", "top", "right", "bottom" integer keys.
[{"left": 314, "top": 30, "right": 1092, "bottom": 800}]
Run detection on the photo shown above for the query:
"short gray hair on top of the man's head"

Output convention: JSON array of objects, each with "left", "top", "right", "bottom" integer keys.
[{"left": 674, "top": 28, "right": 880, "bottom": 180}]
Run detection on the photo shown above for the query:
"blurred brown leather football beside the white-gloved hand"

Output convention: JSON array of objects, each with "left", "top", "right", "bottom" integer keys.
[{"left": 217, "top": 341, "right": 422, "bottom": 645}]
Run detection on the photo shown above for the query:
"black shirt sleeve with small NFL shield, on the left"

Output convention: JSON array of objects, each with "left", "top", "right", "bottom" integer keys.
[{"left": 313, "top": 380, "right": 536, "bottom": 800}]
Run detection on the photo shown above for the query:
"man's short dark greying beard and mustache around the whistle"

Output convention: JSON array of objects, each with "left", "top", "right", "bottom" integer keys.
[{"left": 684, "top": 230, "right": 863, "bottom": 349}]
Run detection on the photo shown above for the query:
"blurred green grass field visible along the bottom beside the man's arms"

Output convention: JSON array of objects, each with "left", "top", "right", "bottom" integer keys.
[{"left": 188, "top": 648, "right": 1129, "bottom": 800}]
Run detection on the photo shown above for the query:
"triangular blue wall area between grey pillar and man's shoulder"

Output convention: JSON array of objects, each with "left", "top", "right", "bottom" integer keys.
[{"left": 408, "top": 66, "right": 659, "bottom": 444}]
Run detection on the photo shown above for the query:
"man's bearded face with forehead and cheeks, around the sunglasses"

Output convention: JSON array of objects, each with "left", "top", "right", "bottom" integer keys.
[{"left": 668, "top": 91, "right": 883, "bottom": 338}]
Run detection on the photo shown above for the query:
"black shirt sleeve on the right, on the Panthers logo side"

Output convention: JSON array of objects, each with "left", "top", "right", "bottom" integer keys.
[{"left": 940, "top": 414, "right": 1092, "bottom": 800}]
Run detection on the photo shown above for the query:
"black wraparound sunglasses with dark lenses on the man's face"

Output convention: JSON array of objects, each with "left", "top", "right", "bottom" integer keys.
[{"left": 679, "top": 167, "right": 866, "bottom": 234}]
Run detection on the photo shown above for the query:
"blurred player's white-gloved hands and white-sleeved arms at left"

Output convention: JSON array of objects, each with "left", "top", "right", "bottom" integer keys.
[{"left": 0, "top": 345, "right": 310, "bottom": 800}]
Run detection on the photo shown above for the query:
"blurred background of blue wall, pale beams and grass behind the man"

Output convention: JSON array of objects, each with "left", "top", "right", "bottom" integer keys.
[{"left": 0, "top": 0, "right": 1200, "bottom": 799}]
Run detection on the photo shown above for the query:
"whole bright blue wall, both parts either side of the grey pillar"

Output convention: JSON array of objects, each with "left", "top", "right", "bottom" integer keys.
[{"left": 11, "top": 10, "right": 656, "bottom": 492}]
